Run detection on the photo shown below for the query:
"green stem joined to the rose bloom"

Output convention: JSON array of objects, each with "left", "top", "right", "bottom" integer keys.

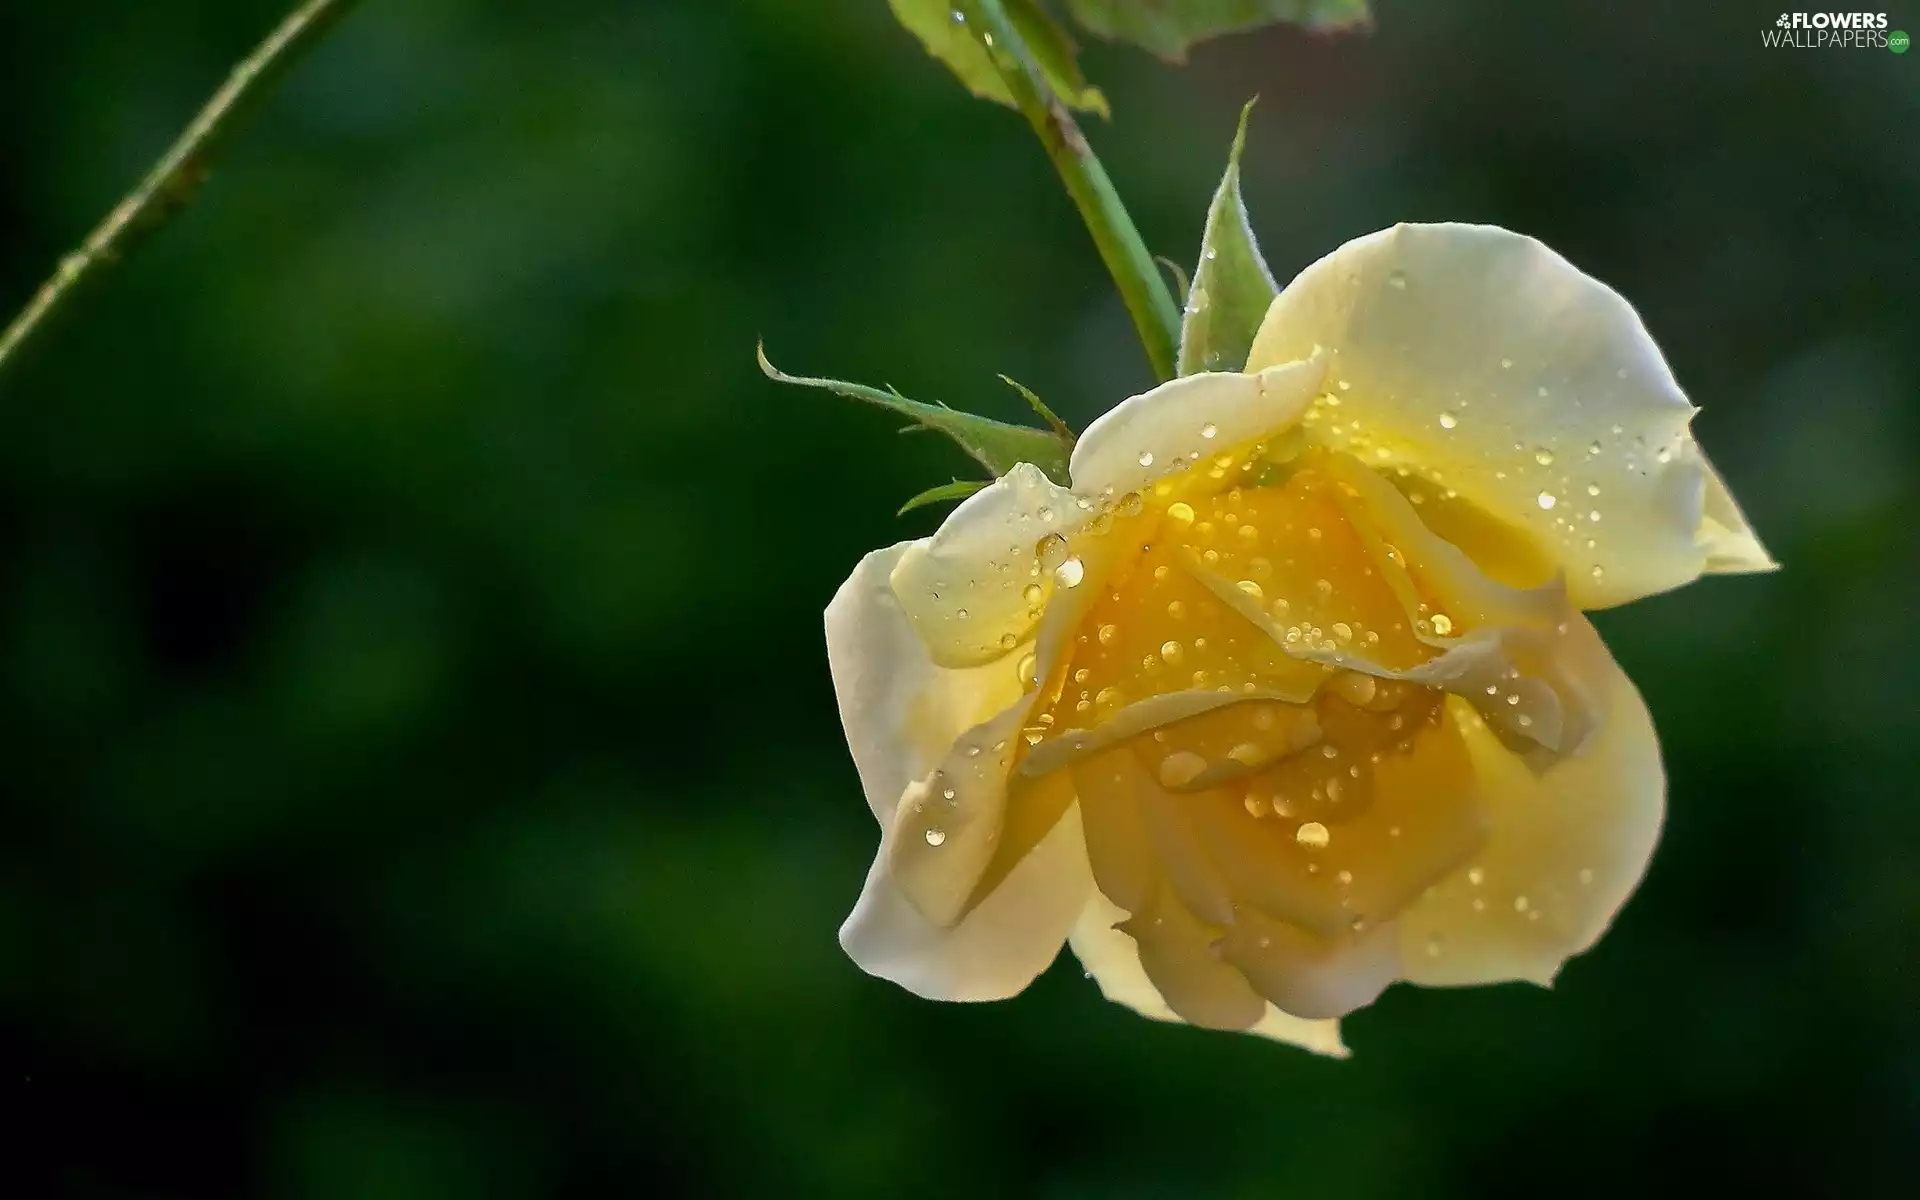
[{"left": 958, "top": 0, "right": 1181, "bottom": 380}]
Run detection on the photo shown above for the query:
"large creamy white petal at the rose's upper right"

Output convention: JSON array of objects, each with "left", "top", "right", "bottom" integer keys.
[{"left": 1248, "top": 225, "right": 1770, "bottom": 609}]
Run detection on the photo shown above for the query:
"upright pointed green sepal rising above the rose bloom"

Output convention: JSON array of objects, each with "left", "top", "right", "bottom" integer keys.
[{"left": 1179, "top": 100, "right": 1279, "bottom": 374}]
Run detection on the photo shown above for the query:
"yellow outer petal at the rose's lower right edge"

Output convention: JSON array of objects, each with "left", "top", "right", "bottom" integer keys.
[{"left": 1400, "top": 668, "right": 1667, "bottom": 985}]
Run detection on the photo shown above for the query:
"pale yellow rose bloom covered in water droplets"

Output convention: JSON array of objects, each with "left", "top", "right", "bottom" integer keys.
[{"left": 826, "top": 225, "right": 1772, "bottom": 1054}]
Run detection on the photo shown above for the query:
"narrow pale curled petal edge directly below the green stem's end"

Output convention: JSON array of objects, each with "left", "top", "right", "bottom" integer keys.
[{"left": 1068, "top": 348, "right": 1327, "bottom": 497}]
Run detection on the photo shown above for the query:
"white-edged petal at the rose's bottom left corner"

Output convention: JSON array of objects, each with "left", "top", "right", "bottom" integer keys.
[{"left": 839, "top": 806, "right": 1092, "bottom": 1000}]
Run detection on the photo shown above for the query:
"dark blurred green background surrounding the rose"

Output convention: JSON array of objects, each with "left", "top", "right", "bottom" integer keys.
[{"left": 0, "top": 0, "right": 1920, "bottom": 1200}]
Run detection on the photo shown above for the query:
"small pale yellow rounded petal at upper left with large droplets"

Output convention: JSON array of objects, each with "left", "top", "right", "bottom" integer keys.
[{"left": 891, "top": 463, "right": 1081, "bottom": 666}]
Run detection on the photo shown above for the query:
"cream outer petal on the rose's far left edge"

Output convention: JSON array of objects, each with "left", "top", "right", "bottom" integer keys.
[{"left": 826, "top": 541, "right": 1020, "bottom": 826}]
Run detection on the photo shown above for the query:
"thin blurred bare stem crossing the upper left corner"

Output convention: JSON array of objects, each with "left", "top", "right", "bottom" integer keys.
[{"left": 0, "top": 0, "right": 357, "bottom": 387}]
